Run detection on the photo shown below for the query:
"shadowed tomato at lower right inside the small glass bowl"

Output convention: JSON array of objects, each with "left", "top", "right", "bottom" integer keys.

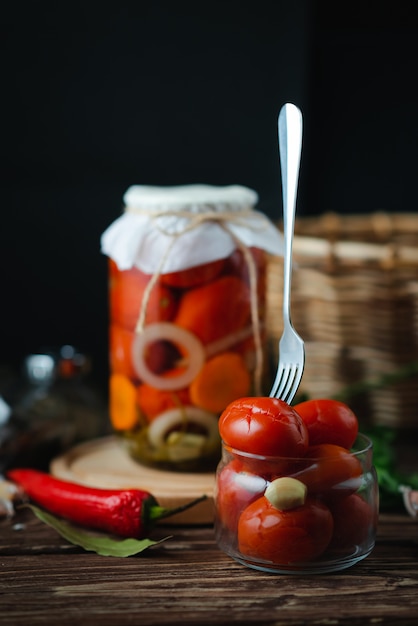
[{"left": 329, "top": 493, "right": 377, "bottom": 553}]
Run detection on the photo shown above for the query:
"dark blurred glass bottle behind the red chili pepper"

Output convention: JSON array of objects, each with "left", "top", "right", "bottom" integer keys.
[{"left": 0, "top": 345, "right": 108, "bottom": 472}]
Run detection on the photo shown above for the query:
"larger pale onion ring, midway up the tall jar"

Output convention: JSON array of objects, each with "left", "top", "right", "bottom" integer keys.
[{"left": 132, "top": 322, "right": 205, "bottom": 391}]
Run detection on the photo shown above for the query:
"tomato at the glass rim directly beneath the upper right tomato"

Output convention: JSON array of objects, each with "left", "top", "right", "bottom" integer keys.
[{"left": 293, "top": 443, "right": 362, "bottom": 497}]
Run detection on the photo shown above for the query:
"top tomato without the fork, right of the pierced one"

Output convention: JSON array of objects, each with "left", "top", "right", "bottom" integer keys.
[{"left": 295, "top": 400, "right": 358, "bottom": 449}]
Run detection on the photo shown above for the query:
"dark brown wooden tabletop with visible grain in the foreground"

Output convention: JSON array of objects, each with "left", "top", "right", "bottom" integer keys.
[{"left": 0, "top": 510, "right": 418, "bottom": 626}]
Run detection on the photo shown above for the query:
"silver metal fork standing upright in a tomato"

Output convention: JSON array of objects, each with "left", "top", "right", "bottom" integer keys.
[{"left": 270, "top": 103, "right": 305, "bottom": 404}]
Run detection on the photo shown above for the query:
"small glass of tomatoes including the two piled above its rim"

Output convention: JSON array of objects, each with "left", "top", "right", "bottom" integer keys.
[{"left": 215, "top": 397, "right": 378, "bottom": 573}]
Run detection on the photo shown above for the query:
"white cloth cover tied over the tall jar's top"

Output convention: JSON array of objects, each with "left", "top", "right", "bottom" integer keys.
[{"left": 101, "top": 185, "right": 283, "bottom": 274}]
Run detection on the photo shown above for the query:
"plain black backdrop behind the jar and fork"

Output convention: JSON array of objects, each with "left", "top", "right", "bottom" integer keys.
[{"left": 0, "top": 0, "right": 418, "bottom": 386}]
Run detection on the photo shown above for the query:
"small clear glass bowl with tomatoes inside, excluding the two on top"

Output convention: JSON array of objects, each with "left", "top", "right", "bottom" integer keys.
[{"left": 215, "top": 434, "right": 378, "bottom": 574}]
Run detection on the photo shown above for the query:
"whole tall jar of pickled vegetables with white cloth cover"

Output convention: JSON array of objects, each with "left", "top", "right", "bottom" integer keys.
[{"left": 102, "top": 185, "right": 282, "bottom": 471}]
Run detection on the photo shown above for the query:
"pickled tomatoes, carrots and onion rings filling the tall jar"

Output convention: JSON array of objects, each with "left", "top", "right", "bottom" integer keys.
[{"left": 109, "top": 250, "right": 264, "bottom": 471}]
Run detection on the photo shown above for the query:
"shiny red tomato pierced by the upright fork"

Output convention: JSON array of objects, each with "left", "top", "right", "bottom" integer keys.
[{"left": 219, "top": 397, "right": 308, "bottom": 458}]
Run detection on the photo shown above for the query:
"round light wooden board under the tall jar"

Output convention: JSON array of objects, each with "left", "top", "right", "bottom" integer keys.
[{"left": 50, "top": 437, "right": 215, "bottom": 524}]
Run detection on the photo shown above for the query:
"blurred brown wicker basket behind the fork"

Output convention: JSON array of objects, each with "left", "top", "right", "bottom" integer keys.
[{"left": 267, "top": 213, "right": 418, "bottom": 429}]
